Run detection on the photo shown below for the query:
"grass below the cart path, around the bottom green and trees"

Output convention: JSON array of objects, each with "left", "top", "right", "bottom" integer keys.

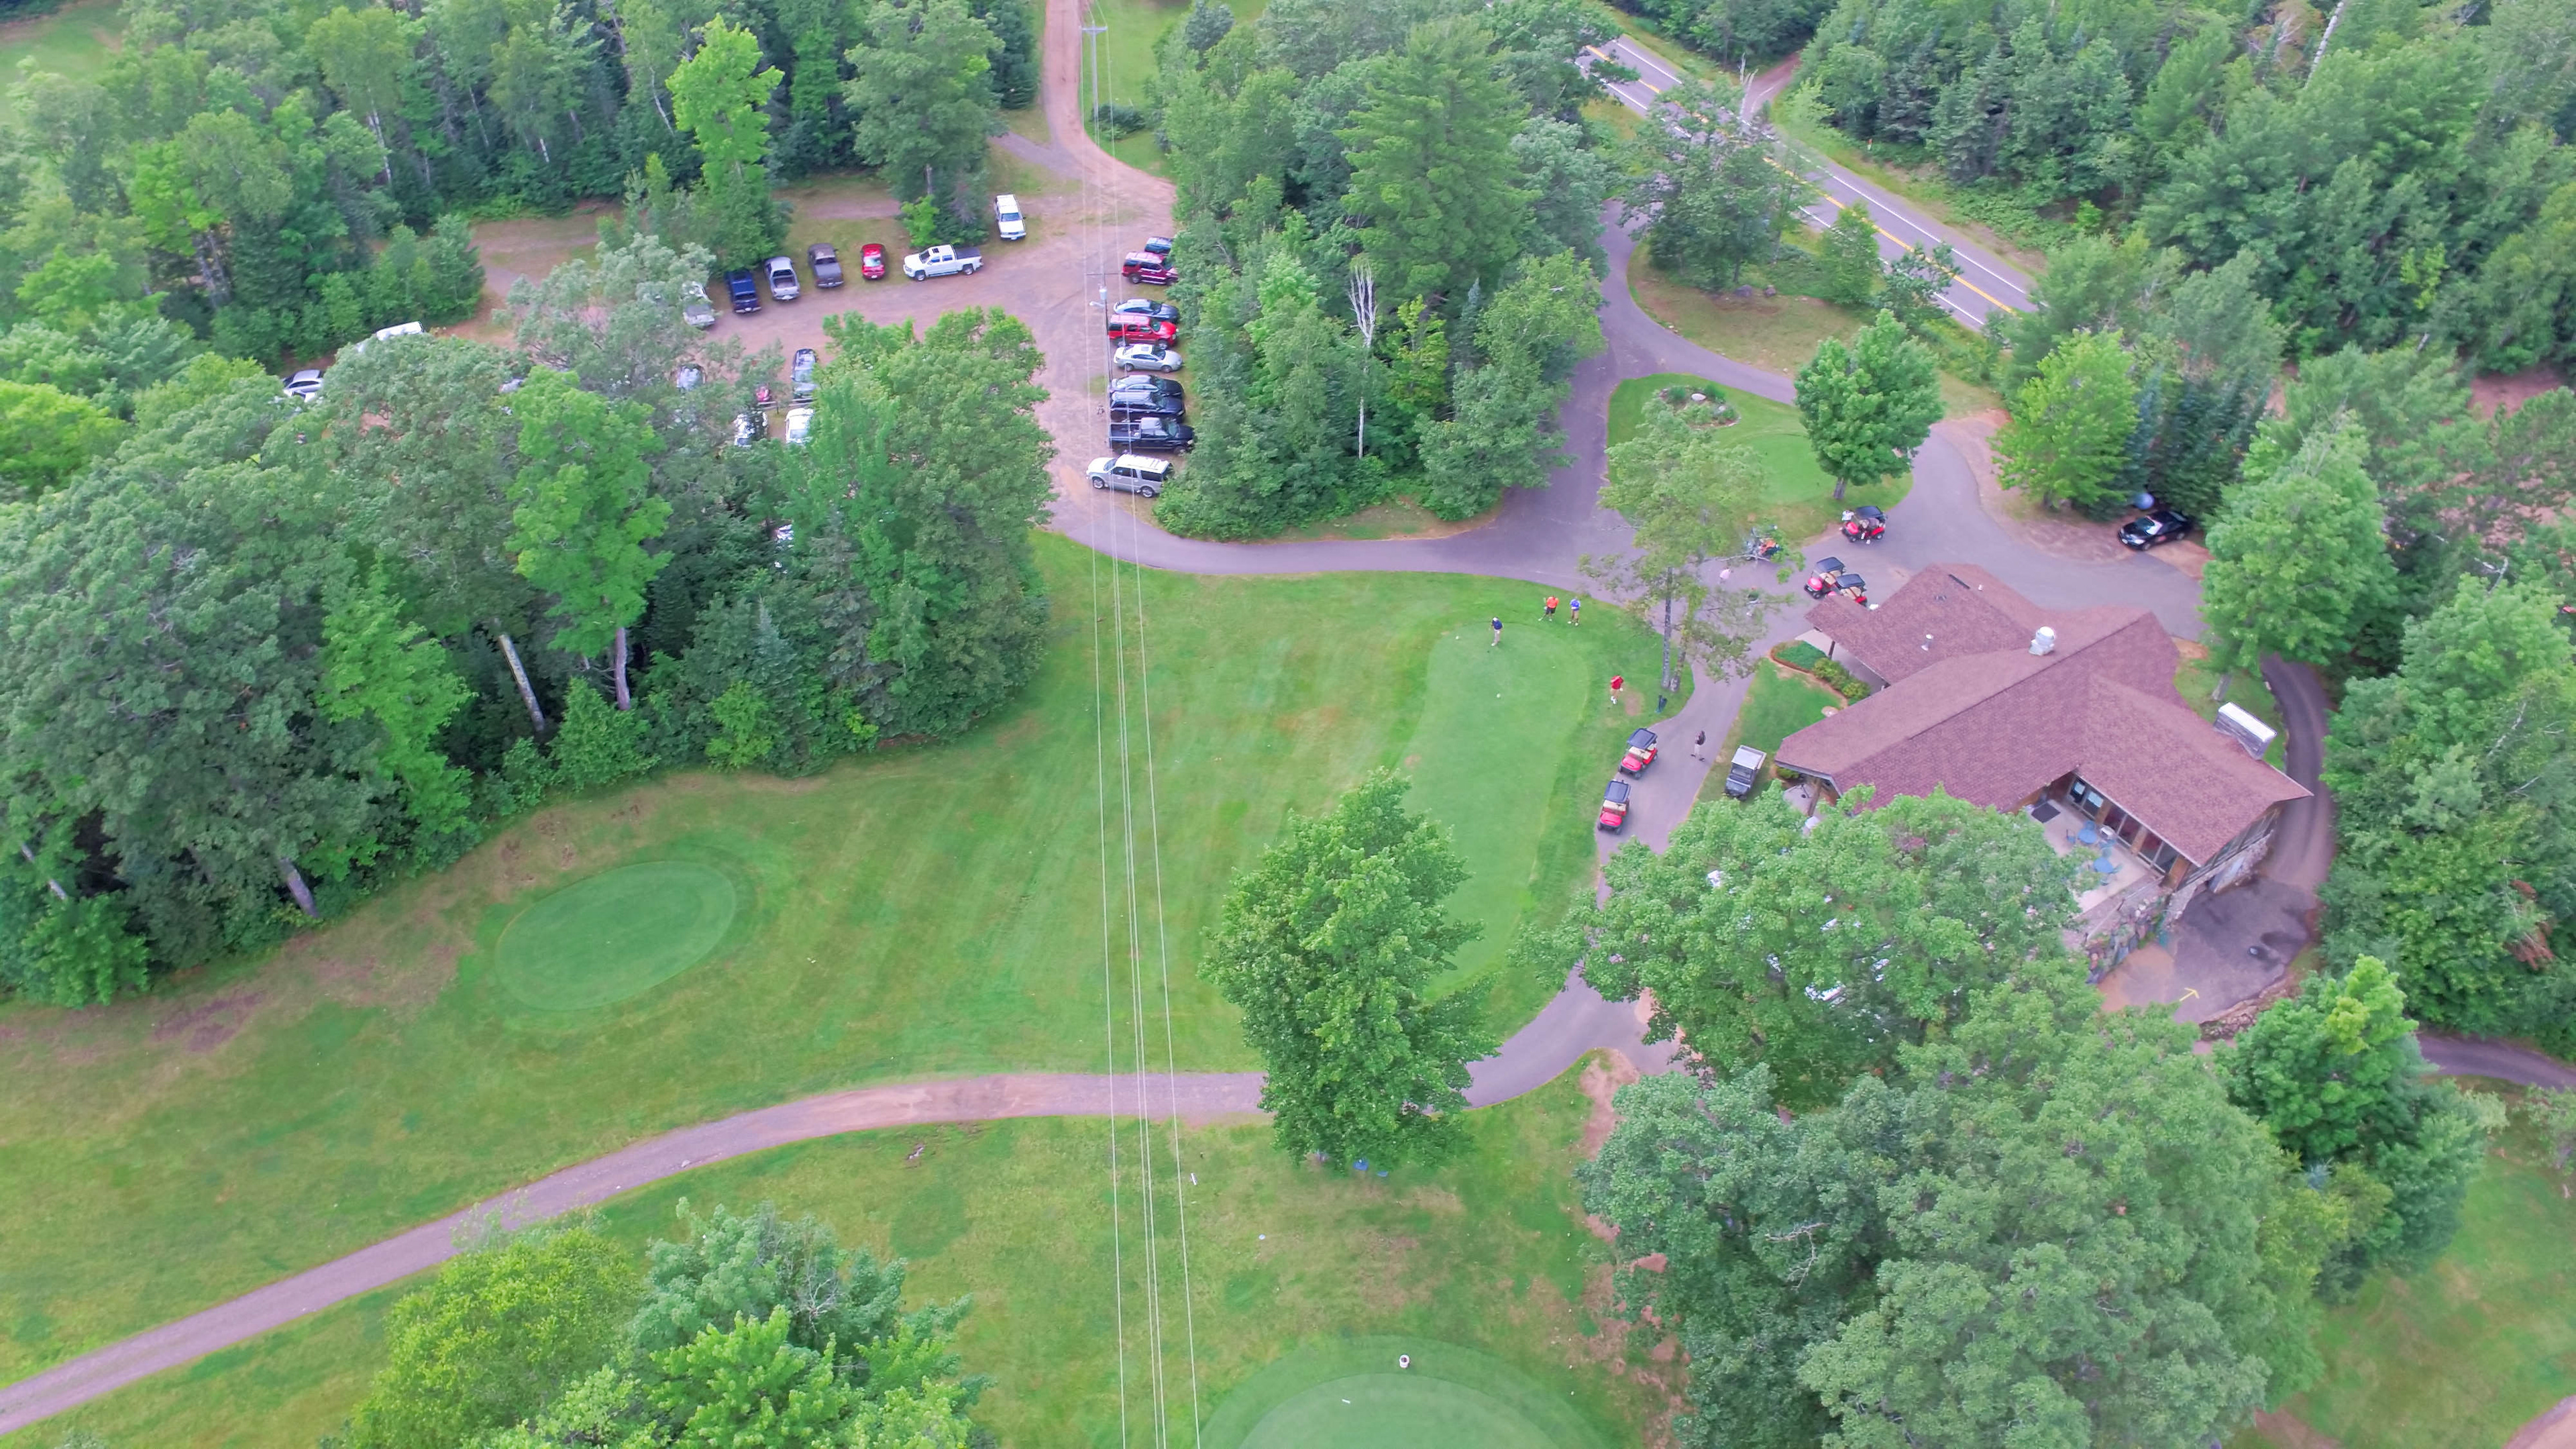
[{"left": 0, "top": 1057, "right": 1659, "bottom": 1449}]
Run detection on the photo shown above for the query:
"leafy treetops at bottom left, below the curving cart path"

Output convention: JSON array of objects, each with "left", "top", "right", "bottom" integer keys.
[{"left": 345, "top": 1201, "right": 987, "bottom": 1449}]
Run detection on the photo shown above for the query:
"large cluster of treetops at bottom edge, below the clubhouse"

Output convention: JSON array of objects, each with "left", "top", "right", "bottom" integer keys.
[{"left": 1576, "top": 957, "right": 2313, "bottom": 1449}]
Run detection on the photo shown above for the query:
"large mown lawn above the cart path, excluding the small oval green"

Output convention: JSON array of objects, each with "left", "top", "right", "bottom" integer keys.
[{"left": 0, "top": 536, "right": 1656, "bottom": 1382}]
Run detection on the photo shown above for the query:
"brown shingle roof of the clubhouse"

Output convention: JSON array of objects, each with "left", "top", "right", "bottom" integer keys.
[{"left": 1780, "top": 565, "right": 2308, "bottom": 861}]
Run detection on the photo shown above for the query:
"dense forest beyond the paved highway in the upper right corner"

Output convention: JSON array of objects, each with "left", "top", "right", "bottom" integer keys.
[{"left": 1803, "top": 0, "right": 2576, "bottom": 371}]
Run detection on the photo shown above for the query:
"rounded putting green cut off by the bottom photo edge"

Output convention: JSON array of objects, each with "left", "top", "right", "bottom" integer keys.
[{"left": 1208, "top": 1338, "right": 1602, "bottom": 1449}]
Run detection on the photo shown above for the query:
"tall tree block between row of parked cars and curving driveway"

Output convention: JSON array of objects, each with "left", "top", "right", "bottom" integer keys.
[{"left": 1154, "top": 0, "right": 1613, "bottom": 536}]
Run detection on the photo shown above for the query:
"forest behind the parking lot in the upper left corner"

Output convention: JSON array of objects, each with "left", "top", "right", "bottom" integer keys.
[{"left": 0, "top": 0, "right": 1038, "bottom": 371}]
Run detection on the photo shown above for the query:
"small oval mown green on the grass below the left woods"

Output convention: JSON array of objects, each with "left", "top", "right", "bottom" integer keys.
[{"left": 497, "top": 861, "right": 734, "bottom": 1011}]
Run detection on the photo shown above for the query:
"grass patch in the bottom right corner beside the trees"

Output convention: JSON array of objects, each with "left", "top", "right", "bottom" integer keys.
[{"left": 2236, "top": 1083, "right": 2576, "bottom": 1449}]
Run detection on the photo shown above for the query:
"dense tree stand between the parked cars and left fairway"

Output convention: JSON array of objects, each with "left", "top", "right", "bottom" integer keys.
[{"left": 0, "top": 235, "right": 1051, "bottom": 1006}]
